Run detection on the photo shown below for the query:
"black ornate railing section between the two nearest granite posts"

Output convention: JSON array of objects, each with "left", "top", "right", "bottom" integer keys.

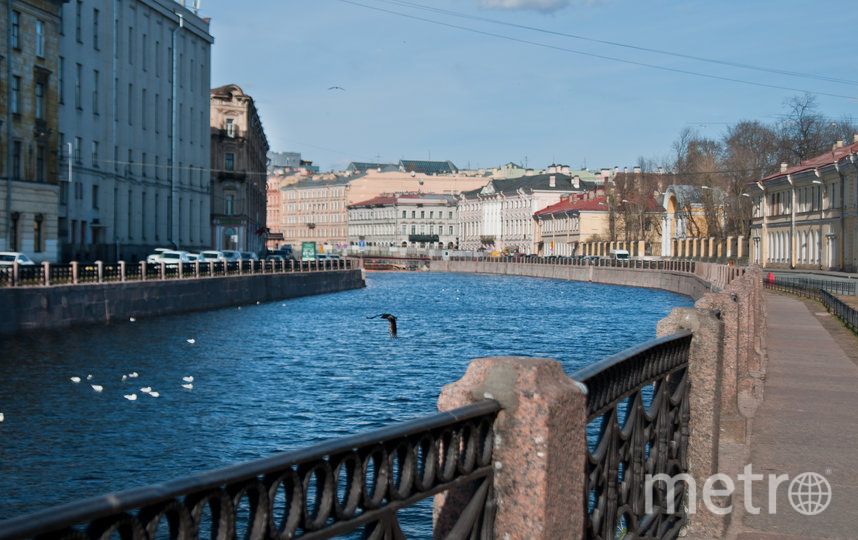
[{"left": 572, "top": 331, "right": 692, "bottom": 539}]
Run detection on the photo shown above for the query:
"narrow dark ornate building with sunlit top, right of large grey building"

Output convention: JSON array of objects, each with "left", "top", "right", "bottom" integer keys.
[{"left": 211, "top": 84, "right": 268, "bottom": 255}]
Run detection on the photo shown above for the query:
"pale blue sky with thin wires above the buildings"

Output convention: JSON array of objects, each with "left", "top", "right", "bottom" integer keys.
[{"left": 200, "top": 0, "right": 858, "bottom": 170}]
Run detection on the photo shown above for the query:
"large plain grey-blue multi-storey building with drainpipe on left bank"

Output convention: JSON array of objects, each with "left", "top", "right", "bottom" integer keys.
[{"left": 58, "top": 0, "right": 213, "bottom": 261}]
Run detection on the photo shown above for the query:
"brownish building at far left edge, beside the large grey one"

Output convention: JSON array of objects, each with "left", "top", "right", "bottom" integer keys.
[{"left": 0, "top": 0, "right": 63, "bottom": 262}]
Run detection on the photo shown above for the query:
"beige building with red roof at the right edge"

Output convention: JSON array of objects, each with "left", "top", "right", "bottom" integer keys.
[{"left": 749, "top": 134, "right": 858, "bottom": 272}]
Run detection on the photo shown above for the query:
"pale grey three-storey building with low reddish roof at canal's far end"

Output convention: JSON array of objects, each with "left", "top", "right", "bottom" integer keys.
[{"left": 348, "top": 193, "right": 458, "bottom": 252}]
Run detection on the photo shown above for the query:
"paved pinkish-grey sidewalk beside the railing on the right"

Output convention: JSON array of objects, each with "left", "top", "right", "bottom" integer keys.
[{"left": 731, "top": 293, "right": 858, "bottom": 540}]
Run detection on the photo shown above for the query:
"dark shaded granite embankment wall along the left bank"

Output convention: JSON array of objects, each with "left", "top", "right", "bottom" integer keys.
[{"left": 0, "top": 269, "right": 365, "bottom": 334}]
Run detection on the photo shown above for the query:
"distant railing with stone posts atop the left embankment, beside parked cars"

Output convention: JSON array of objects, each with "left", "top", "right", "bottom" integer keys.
[{"left": 0, "top": 259, "right": 360, "bottom": 287}]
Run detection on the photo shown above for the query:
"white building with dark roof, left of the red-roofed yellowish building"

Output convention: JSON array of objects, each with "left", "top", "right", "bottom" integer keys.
[{"left": 459, "top": 166, "right": 596, "bottom": 253}]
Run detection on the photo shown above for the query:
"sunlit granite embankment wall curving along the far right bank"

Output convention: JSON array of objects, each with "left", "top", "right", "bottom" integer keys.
[{"left": 429, "top": 260, "right": 711, "bottom": 300}]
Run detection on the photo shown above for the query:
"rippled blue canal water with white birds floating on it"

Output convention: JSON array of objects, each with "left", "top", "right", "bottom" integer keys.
[{"left": 0, "top": 272, "right": 692, "bottom": 519}]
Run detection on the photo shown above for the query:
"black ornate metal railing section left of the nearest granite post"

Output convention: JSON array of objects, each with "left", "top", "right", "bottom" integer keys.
[{"left": 0, "top": 400, "right": 500, "bottom": 540}]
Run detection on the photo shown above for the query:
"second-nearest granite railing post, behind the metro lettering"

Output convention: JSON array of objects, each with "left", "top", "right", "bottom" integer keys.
[{"left": 657, "top": 308, "right": 732, "bottom": 538}]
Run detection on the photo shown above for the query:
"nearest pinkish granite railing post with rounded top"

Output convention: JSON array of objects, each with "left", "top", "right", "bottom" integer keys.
[{"left": 434, "top": 356, "right": 587, "bottom": 540}]
